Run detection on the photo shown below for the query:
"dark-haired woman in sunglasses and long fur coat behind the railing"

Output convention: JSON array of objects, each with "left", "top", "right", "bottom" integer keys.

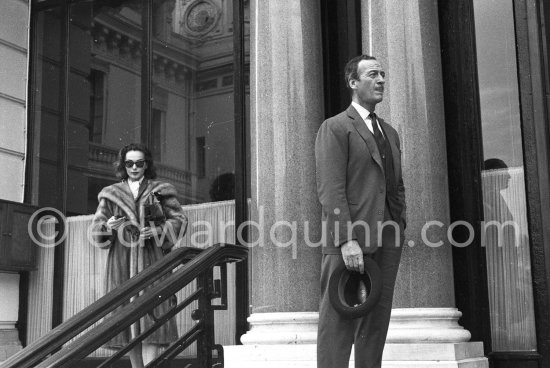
[{"left": 93, "top": 144, "right": 187, "bottom": 368}]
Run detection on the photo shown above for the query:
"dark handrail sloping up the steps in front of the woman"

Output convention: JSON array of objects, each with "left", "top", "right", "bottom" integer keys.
[{"left": 0, "top": 244, "right": 248, "bottom": 368}]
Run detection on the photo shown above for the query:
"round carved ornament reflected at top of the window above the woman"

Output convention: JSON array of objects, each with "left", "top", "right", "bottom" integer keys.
[{"left": 182, "top": 0, "right": 221, "bottom": 37}]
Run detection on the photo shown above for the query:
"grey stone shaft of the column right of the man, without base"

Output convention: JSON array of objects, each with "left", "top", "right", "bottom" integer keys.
[{"left": 362, "top": 0, "right": 455, "bottom": 308}]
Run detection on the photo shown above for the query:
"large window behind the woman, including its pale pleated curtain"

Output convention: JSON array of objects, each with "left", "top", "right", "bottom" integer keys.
[{"left": 29, "top": 0, "right": 248, "bottom": 356}]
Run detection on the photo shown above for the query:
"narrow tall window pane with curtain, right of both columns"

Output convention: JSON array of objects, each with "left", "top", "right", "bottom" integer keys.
[{"left": 474, "top": 0, "right": 536, "bottom": 351}]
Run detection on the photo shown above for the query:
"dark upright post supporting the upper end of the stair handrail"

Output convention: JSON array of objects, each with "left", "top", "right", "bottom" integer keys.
[{"left": 197, "top": 268, "right": 214, "bottom": 368}]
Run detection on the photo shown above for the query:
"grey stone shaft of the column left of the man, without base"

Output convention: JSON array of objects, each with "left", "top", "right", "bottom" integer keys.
[{"left": 245, "top": 0, "right": 323, "bottom": 316}]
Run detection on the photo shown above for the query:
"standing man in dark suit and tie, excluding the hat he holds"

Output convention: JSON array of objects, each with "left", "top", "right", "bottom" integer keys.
[{"left": 315, "top": 55, "right": 405, "bottom": 368}]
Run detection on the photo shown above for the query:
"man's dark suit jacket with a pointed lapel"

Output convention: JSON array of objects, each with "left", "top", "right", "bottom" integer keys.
[{"left": 315, "top": 105, "right": 405, "bottom": 254}]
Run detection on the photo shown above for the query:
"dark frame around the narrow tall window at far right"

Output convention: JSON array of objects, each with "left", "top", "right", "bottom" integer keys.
[{"left": 438, "top": 0, "right": 550, "bottom": 368}]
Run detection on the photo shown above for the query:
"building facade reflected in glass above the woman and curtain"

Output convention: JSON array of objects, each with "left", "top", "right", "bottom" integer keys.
[{"left": 37, "top": 1, "right": 248, "bottom": 213}]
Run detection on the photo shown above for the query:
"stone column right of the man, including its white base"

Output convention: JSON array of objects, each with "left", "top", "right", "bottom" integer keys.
[{"left": 361, "top": 0, "right": 488, "bottom": 367}]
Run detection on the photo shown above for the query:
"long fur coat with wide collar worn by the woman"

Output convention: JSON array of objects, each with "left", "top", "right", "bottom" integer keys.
[{"left": 92, "top": 178, "right": 187, "bottom": 348}]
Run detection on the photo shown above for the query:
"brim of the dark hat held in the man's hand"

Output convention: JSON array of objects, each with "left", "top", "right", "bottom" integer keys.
[{"left": 328, "top": 256, "right": 382, "bottom": 319}]
